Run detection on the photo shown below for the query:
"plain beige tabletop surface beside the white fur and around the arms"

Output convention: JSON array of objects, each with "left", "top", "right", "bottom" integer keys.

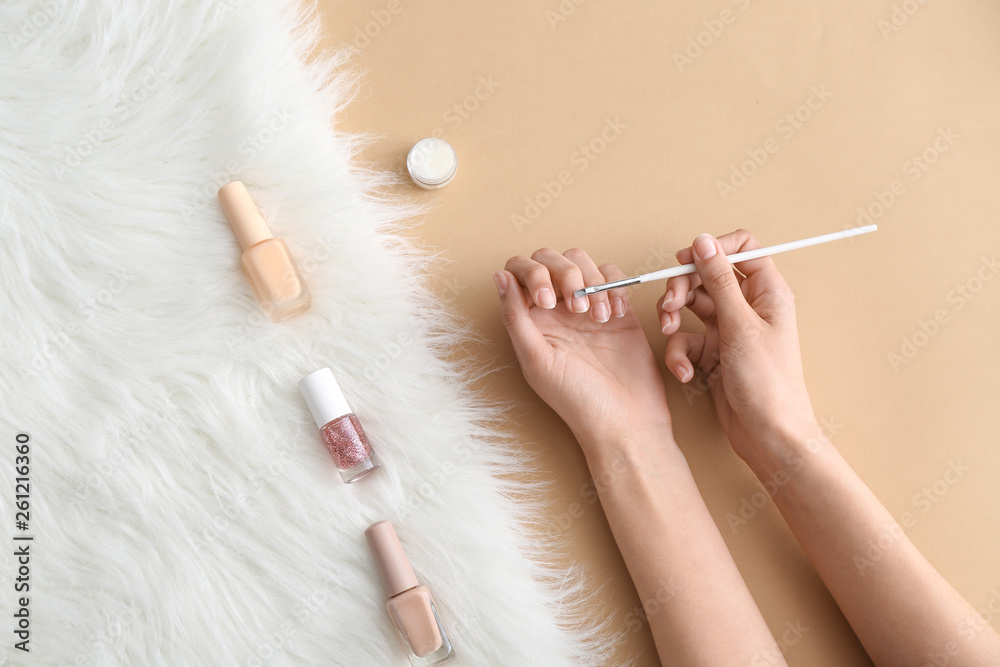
[{"left": 320, "top": 0, "right": 1000, "bottom": 665}]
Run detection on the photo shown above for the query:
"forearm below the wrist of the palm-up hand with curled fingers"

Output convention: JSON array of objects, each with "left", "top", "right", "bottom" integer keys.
[{"left": 580, "top": 432, "right": 784, "bottom": 665}]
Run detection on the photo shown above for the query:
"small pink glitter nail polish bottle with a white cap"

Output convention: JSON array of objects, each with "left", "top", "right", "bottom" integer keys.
[{"left": 299, "top": 368, "right": 381, "bottom": 484}]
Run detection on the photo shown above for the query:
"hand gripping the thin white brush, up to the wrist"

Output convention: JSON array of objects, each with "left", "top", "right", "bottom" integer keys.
[{"left": 657, "top": 229, "right": 819, "bottom": 465}]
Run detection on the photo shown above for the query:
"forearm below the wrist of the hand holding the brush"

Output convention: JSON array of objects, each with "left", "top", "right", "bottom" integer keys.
[{"left": 751, "top": 428, "right": 1000, "bottom": 666}]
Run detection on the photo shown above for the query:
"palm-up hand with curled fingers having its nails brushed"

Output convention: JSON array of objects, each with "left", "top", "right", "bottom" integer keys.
[{"left": 493, "top": 248, "right": 672, "bottom": 448}]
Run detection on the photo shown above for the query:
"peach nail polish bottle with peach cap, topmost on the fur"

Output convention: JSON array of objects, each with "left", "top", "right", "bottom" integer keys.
[{"left": 219, "top": 181, "right": 312, "bottom": 322}]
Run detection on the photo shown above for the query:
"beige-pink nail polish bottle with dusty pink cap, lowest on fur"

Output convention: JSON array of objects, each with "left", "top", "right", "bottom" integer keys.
[{"left": 365, "top": 521, "right": 455, "bottom": 667}]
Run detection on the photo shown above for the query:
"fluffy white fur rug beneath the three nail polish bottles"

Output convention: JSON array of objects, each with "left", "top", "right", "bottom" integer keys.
[{"left": 0, "top": 0, "right": 607, "bottom": 667}]
